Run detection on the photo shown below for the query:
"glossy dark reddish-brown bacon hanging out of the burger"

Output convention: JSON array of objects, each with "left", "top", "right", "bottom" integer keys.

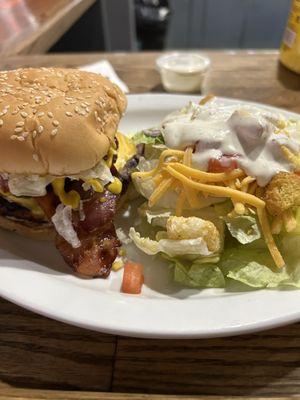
[{"left": 38, "top": 188, "right": 121, "bottom": 278}]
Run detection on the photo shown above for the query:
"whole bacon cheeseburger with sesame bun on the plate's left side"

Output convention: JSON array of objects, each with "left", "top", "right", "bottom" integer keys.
[{"left": 0, "top": 68, "right": 136, "bottom": 277}]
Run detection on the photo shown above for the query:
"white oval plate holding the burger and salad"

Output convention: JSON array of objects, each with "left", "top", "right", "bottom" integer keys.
[{"left": 0, "top": 94, "right": 300, "bottom": 338}]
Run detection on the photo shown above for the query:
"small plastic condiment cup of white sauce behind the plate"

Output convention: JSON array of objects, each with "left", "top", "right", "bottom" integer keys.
[{"left": 156, "top": 52, "right": 210, "bottom": 93}]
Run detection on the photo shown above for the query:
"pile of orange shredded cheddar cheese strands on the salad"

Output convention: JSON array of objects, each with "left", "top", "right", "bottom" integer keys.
[{"left": 133, "top": 148, "right": 286, "bottom": 268}]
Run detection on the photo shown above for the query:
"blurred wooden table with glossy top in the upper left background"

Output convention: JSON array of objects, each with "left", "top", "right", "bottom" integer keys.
[{"left": 0, "top": 0, "right": 95, "bottom": 56}]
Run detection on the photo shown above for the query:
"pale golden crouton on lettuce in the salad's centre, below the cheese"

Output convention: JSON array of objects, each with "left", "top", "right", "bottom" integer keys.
[{"left": 166, "top": 217, "right": 221, "bottom": 252}]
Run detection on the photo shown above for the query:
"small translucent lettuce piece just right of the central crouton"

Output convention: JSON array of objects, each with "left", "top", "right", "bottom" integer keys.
[{"left": 223, "top": 215, "right": 261, "bottom": 244}]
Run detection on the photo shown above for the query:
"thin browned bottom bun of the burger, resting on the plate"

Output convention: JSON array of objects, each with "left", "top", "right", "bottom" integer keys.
[{"left": 0, "top": 215, "right": 55, "bottom": 240}]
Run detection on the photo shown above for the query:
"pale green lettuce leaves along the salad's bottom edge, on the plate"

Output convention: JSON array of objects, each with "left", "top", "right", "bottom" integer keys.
[{"left": 163, "top": 237, "right": 300, "bottom": 289}]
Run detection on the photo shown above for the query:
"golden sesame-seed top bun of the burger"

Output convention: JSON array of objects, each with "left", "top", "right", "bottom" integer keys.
[{"left": 0, "top": 68, "right": 126, "bottom": 176}]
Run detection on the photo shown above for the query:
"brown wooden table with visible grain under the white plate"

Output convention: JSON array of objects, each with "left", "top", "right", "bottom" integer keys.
[{"left": 0, "top": 51, "right": 300, "bottom": 400}]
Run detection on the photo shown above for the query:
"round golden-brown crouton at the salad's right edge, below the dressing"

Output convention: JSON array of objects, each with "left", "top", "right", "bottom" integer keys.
[{"left": 264, "top": 172, "right": 300, "bottom": 215}]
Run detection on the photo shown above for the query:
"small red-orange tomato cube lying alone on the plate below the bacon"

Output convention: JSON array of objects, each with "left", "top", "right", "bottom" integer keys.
[{"left": 122, "top": 261, "right": 144, "bottom": 294}]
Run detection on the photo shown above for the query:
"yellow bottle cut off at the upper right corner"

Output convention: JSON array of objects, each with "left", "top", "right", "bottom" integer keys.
[{"left": 280, "top": 0, "right": 300, "bottom": 74}]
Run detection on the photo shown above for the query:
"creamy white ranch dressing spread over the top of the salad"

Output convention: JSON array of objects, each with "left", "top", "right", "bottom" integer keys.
[{"left": 162, "top": 101, "right": 300, "bottom": 186}]
